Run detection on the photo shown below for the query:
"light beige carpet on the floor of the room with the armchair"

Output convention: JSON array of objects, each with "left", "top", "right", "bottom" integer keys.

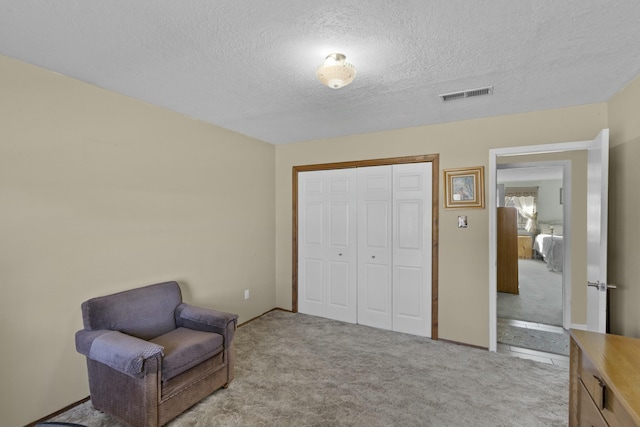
[{"left": 50, "top": 311, "right": 569, "bottom": 427}]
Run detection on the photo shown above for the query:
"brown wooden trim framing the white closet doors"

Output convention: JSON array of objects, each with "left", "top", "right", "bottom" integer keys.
[{"left": 291, "top": 154, "right": 440, "bottom": 340}]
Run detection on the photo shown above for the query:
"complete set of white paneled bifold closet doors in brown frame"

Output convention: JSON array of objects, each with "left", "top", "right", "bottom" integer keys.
[{"left": 298, "top": 163, "right": 433, "bottom": 336}]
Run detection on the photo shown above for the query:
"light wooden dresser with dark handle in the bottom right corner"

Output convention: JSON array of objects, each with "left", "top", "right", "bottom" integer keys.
[{"left": 569, "top": 330, "right": 640, "bottom": 427}]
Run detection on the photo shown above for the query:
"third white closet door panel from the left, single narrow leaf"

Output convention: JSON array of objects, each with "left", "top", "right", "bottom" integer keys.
[{"left": 358, "top": 166, "right": 393, "bottom": 329}]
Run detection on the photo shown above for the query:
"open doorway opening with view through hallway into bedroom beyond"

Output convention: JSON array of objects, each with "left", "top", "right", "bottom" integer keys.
[{"left": 496, "top": 160, "right": 571, "bottom": 364}]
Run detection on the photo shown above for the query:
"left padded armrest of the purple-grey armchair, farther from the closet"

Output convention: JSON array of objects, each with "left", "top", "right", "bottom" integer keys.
[{"left": 76, "top": 330, "right": 164, "bottom": 378}]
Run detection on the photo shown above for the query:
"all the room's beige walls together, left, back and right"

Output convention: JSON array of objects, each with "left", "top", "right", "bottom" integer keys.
[{"left": 0, "top": 49, "right": 640, "bottom": 425}]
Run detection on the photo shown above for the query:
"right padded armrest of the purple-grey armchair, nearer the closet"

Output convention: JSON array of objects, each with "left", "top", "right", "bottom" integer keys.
[{"left": 175, "top": 303, "right": 238, "bottom": 346}]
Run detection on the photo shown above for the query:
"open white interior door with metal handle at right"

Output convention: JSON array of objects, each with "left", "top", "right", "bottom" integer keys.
[{"left": 587, "top": 129, "right": 609, "bottom": 333}]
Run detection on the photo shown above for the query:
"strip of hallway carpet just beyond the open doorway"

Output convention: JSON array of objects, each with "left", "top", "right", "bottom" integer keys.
[{"left": 498, "top": 322, "right": 569, "bottom": 356}]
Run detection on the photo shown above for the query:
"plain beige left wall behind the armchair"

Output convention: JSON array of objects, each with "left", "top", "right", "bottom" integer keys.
[{"left": 0, "top": 56, "right": 276, "bottom": 426}]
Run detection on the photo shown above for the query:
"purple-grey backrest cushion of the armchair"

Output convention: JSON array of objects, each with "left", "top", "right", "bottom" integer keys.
[{"left": 82, "top": 282, "right": 182, "bottom": 340}]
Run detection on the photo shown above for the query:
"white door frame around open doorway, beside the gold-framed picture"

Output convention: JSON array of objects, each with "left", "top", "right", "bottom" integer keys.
[{"left": 488, "top": 140, "right": 593, "bottom": 352}]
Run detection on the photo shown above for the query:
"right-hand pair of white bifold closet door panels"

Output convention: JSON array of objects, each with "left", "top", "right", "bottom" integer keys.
[{"left": 357, "top": 163, "right": 433, "bottom": 336}]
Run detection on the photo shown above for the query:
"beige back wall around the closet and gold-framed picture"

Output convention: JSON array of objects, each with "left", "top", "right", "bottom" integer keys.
[{"left": 276, "top": 104, "right": 607, "bottom": 347}]
